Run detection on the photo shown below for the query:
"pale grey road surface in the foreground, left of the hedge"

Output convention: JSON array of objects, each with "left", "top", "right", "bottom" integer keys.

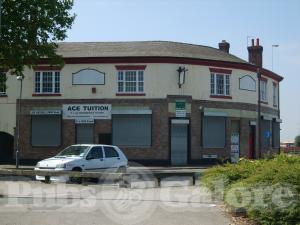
[{"left": 0, "top": 181, "right": 231, "bottom": 225}]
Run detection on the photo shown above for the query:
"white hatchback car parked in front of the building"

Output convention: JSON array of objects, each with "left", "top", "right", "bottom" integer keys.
[{"left": 34, "top": 144, "right": 128, "bottom": 182}]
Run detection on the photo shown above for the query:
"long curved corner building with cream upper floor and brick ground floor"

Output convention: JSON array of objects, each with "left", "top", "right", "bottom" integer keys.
[{"left": 0, "top": 39, "right": 283, "bottom": 165}]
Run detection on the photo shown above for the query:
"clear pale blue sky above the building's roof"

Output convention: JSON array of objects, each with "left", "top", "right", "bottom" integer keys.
[{"left": 66, "top": 0, "right": 300, "bottom": 141}]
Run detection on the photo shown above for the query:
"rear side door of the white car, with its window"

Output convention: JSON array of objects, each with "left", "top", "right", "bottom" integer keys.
[{"left": 103, "top": 146, "right": 121, "bottom": 172}]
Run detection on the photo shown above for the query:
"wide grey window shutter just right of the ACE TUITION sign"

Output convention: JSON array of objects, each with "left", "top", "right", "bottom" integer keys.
[{"left": 113, "top": 114, "right": 151, "bottom": 147}]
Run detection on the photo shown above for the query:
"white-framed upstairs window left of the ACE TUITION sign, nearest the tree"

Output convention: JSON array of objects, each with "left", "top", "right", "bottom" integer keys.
[{"left": 34, "top": 71, "right": 60, "bottom": 93}]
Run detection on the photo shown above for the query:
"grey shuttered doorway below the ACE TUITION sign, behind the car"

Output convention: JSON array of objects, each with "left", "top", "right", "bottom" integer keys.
[{"left": 76, "top": 123, "right": 94, "bottom": 144}]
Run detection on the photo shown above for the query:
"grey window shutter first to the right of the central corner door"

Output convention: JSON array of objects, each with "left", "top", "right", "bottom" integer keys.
[{"left": 202, "top": 116, "right": 226, "bottom": 148}]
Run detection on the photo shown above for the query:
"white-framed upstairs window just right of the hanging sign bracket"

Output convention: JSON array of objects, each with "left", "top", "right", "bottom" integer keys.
[{"left": 210, "top": 73, "right": 231, "bottom": 96}]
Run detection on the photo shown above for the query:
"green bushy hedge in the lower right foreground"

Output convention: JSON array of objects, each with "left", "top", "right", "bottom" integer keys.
[{"left": 201, "top": 155, "right": 300, "bottom": 225}]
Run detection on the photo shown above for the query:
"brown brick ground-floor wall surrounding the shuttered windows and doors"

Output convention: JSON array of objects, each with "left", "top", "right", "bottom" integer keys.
[{"left": 15, "top": 96, "right": 276, "bottom": 162}]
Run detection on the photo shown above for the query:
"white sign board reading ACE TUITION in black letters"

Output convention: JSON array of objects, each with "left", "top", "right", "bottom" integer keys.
[{"left": 63, "top": 104, "right": 111, "bottom": 120}]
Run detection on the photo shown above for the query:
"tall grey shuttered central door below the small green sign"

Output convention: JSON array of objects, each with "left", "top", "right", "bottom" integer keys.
[{"left": 171, "top": 119, "right": 189, "bottom": 165}]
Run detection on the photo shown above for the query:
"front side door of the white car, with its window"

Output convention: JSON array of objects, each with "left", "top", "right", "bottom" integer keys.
[{"left": 85, "top": 146, "right": 105, "bottom": 171}]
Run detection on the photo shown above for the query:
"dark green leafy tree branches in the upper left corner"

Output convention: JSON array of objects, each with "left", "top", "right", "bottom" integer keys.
[{"left": 0, "top": 0, "right": 75, "bottom": 75}]
